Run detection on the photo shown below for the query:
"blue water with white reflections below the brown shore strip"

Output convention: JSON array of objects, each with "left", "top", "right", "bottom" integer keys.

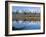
[{"left": 12, "top": 21, "right": 40, "bottom": 30}]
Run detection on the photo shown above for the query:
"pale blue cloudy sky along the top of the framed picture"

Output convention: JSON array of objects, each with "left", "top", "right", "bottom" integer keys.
[{"left": 12, "top": 6, "right": 41, "bottom": 13}]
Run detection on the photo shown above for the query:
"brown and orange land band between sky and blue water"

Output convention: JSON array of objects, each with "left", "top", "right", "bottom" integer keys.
[{"left": 12, "top": 13, "right": 40, "bottom": 21}]
